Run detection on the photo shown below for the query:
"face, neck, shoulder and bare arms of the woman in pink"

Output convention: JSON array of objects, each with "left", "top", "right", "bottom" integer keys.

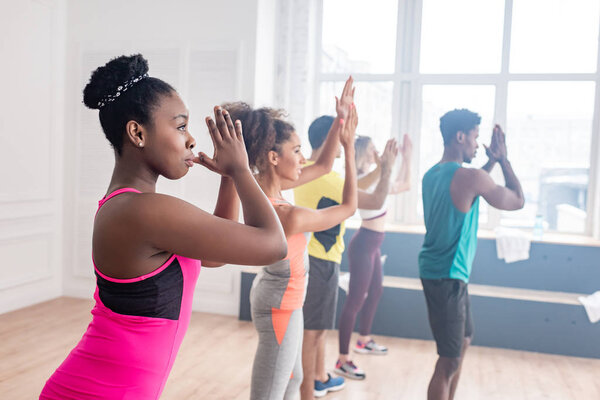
[{"left": 92, "top": 92, "right": 287, "bottom": 279}]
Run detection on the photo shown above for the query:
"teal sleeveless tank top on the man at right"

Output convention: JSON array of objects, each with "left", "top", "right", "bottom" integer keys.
[{"left": 419, "top": 162, "right": 479, "bottom": 283}]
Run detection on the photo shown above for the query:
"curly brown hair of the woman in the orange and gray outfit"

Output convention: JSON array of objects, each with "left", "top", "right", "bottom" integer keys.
[{"left": 222, "top": 101, "right": 295, "bottom": 172}]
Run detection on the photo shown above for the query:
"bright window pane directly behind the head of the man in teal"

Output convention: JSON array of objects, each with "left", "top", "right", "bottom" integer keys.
[{"left": 417, "top": 85, "right": 495, "bottom": 223}]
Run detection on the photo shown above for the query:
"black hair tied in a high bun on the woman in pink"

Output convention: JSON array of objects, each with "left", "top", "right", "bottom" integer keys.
[{"left": 83, "top": 54, "right": 175, "bottom": 155}]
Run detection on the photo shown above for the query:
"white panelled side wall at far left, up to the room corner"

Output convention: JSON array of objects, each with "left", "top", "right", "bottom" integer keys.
[{"left": 0, "top": 0, "right": 65, "bottom": 313}]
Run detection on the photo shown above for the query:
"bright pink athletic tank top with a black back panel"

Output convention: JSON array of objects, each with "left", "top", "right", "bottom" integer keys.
[{"left": 40, "top": 188, "right": 200, "bottom": 400}]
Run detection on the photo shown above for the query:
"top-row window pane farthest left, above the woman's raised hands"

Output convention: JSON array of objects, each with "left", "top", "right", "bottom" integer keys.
[{"left": 321, "top": 0, "right": 398, "bottom": 74}]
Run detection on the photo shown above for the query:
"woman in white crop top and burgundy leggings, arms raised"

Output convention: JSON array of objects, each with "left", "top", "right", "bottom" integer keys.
[{"left": 335, "top": 135, "right": 412, "bottom": 379}]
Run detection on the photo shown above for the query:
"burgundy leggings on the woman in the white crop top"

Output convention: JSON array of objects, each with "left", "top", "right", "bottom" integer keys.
[{"left": 339, "top": 228, "right": 385, "bottom": 354}]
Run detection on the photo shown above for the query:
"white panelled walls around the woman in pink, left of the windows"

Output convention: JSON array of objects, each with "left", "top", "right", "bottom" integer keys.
[{"left": 0, "top": 0, "right": 277, "bottom": 315}]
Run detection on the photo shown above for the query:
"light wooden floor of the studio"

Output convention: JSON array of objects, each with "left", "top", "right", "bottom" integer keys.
[{"left": 0, "top": 298, "right": 600, "bottom": 400}]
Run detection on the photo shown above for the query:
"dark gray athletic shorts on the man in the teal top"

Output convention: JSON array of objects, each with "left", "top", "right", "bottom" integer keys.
[{"left": 421, "top": 279, "right": 473, "bottom": 358}]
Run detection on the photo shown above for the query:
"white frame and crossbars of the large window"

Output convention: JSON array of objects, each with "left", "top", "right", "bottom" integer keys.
[{"left": 313, "top": 0, "right": 600, "bottom": 239}]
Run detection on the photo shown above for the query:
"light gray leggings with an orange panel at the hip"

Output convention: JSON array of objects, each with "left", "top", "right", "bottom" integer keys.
[{"left": 250, "top": 305, "right": 304, "bottom": 400}]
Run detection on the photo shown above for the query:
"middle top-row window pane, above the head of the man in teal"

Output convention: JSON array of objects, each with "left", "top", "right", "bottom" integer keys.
[{"left": 420, "top": 0, "right": 504, "bottom": 74}]
